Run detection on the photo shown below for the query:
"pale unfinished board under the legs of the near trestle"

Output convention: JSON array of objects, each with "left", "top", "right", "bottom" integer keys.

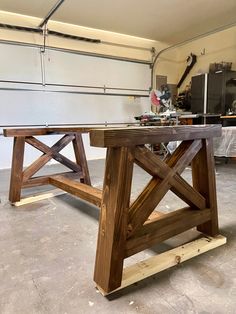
[{"left": 98, "top": 235, "right": 226, "bottom": 296}]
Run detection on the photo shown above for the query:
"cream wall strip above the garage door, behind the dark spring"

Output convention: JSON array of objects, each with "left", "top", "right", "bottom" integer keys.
[{"left": 0, "top": 11, "right": 162, "bottom": 61}]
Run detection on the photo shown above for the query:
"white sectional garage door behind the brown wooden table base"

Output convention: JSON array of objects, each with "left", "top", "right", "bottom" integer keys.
[{"left": 0, "top": 44, "right": 151, "bottom": 168}]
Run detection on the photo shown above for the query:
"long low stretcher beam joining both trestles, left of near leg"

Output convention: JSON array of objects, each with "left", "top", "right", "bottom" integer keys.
[{"left": 49, "top": 175, "right": 102, "bottom": 206}]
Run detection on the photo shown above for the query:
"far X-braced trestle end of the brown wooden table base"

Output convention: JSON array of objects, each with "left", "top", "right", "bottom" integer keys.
[{"left": 3, "top": 127, "right": 91, "bottom": 204}]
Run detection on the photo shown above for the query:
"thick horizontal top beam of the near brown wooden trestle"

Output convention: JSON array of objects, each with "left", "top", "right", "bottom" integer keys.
[{"left": 90, "top": 124, "right": 221, "bottom": 147}]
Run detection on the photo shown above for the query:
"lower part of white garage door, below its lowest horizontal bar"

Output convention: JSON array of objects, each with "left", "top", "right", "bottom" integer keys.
[{"left": 0, "top": 91, "right": 149, "bottom": 169}]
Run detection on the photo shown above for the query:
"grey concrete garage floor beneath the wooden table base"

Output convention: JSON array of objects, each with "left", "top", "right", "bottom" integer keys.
[{"left": 0, "top": 160, "right": 236, "bottom": 314}]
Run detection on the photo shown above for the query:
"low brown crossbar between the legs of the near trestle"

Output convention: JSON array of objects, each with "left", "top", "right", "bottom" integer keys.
[{"left": 126, "top": 207, "right": 211, "bottom": 257}]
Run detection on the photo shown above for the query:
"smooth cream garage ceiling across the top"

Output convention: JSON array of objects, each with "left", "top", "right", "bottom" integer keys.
[{"left": 0, "top": 0, "right": 236, "bottom": 44}]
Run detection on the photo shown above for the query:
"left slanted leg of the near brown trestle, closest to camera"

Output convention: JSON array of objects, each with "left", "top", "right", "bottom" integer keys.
[{"left": 94, "top": 147, "right": 133, "bottom": 292}]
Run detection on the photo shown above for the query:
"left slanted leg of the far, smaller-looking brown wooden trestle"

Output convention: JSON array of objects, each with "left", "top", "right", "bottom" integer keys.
[{"left": 9, "top": 136, "right": 25, "bottom": 203}]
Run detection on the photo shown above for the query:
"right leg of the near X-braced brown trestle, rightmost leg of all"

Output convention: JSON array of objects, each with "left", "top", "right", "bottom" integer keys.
[{"left": 192, "top": 138, "right": 219, "bottom": 236}]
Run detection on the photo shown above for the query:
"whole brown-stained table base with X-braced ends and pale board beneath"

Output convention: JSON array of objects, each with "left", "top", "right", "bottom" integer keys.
[{"left": 4, "top": 125, "right": 226, "bottom": 295}]
